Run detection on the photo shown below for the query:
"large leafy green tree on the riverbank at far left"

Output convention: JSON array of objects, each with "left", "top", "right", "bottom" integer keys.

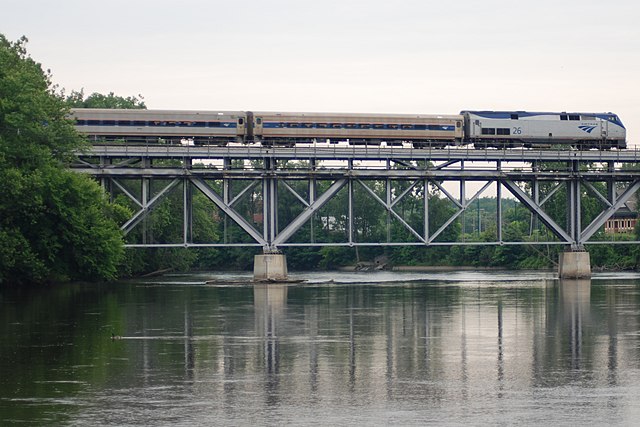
[{"left": 0, "top": 34, "right": 124, "bottom": 283}]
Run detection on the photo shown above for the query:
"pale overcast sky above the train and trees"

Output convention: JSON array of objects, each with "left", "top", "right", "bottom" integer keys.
[{"left": 5, "top": 0, "right": 640, "bottom": 145}]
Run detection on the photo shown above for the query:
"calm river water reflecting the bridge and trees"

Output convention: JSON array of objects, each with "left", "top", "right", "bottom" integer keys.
[{"left": 0, "top": 272, "right": 640, "bottom": 425}]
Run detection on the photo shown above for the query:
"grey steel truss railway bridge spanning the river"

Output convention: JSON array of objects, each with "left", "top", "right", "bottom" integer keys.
[{"left": 73, "top": 145, "right": 640, "bottom": 275}]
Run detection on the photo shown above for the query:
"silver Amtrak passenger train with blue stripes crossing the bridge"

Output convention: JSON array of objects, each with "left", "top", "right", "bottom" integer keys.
[{"left": 71, "top": 108, "right": 627, "bottom": 150}]
